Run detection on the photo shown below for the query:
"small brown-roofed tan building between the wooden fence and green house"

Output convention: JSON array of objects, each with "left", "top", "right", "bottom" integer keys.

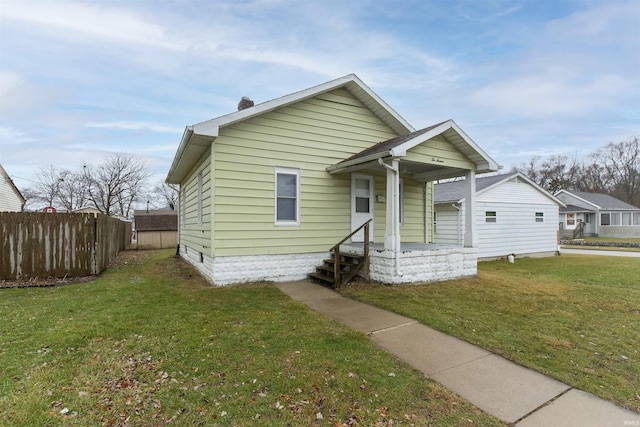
[{"left": 133, "top": 209, "right": 178, "bottom": 249}]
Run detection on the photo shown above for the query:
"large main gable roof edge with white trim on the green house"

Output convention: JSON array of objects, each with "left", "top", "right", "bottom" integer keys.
[{"left": 166, "top": 74, "right": 414, "bottom": 184}]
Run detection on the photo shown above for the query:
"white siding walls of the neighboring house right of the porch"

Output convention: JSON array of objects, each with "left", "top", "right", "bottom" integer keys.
[{"left": 436, "top": 177, "right": 559, "bottom": 258}]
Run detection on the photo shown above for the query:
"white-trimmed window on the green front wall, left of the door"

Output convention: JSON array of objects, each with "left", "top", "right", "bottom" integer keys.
[{"left": 275, "top": 167, "right": 300, "bottom": 226}]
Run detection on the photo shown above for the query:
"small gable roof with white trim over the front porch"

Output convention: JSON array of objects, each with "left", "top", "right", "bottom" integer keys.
[{"left": 327, "top": 120, "right": 499, "bottom": 173}]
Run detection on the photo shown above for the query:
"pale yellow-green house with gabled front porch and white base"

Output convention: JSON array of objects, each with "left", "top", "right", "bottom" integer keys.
[{"left": 166, "top": 74, "right": 498, "bottom": 285}]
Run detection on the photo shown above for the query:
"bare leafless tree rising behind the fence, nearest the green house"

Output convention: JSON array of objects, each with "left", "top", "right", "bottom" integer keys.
[{"left": 83, "top": 154, "right": 150, "bottom": 218}]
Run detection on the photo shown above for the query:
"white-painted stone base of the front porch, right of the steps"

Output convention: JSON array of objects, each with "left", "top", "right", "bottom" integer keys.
[{"left": 340, "top": 247, "right": 478, "bottom": 284}]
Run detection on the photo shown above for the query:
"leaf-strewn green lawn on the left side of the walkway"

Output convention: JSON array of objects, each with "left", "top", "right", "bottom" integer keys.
[{"left": 0, "top": 251, "right": 501, "bottom": 426}]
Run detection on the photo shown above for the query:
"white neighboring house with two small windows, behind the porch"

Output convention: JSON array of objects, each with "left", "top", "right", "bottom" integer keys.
[{"left": 433, "top": 173, "right": 564, "bottom": 259}]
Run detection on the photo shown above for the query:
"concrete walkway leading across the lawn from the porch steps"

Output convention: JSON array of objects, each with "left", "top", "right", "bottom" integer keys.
[{"left": 275, "top": 281, "right": 640, "bottom": 427}]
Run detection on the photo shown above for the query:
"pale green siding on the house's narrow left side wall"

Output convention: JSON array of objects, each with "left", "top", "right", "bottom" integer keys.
[{"left": 180, "top": 152, "right": 212, "bottom": 254}]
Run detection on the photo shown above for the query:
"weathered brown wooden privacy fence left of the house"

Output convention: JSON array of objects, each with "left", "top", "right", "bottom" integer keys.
[{"left": 0, "top": 212, "right": 131, "bottom": 280}]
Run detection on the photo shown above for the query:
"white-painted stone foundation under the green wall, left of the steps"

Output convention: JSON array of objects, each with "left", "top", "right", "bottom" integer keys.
[{"left": 180, "top": 245, "right": 330, "bottom": 286}]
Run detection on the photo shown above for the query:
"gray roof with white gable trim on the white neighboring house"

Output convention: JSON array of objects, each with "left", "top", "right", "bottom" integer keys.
[{"left": 433, "top": 172, "right": 565, "bottom": 206}]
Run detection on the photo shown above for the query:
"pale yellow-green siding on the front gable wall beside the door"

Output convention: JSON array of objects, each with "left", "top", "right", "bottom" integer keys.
[{"left": 214, "top": 89, "right": 396, "bottom": 256}]
